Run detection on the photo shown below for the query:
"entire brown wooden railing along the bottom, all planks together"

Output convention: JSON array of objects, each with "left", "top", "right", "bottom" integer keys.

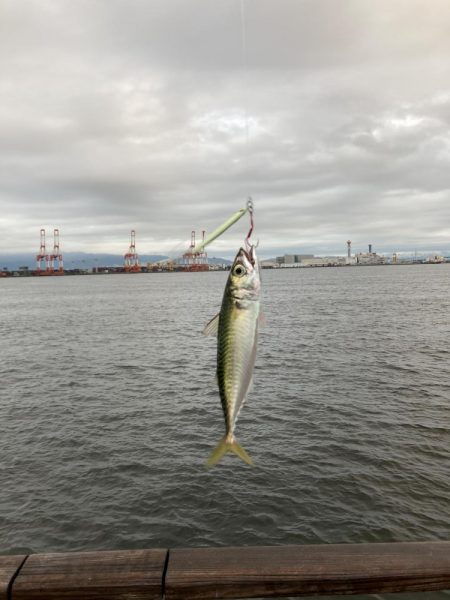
[{"left": 0, "top": 542, "right": 450, "bottom": 600}]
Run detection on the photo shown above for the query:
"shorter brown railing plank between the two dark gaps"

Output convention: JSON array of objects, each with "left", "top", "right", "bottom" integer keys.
[{"left": 12, "top": 550, "right": 167, "bottom": 600}]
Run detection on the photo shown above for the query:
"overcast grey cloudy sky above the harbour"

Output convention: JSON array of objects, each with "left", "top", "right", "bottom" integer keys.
[{"left": 0, "top": 0, "right": 450, "bottom": 257}]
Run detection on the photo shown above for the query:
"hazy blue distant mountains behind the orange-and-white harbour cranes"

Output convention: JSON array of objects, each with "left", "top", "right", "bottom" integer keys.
[{"left": 0, "top": 252, "right": 231, "bottom": 271}]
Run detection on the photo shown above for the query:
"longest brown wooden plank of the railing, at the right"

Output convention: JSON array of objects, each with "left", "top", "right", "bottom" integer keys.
[{"left": 165, "top": 542, "right": 450, "bottom": 600}]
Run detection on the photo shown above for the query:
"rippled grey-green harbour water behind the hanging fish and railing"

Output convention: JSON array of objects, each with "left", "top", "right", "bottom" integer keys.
[{"left": 0, "top": 265, "right": 450, "bottom": 598}]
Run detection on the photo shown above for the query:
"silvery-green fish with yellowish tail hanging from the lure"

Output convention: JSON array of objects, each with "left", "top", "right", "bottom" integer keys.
[{"left": 203, "top": 245, "right": 261, "bottom": 467}]
